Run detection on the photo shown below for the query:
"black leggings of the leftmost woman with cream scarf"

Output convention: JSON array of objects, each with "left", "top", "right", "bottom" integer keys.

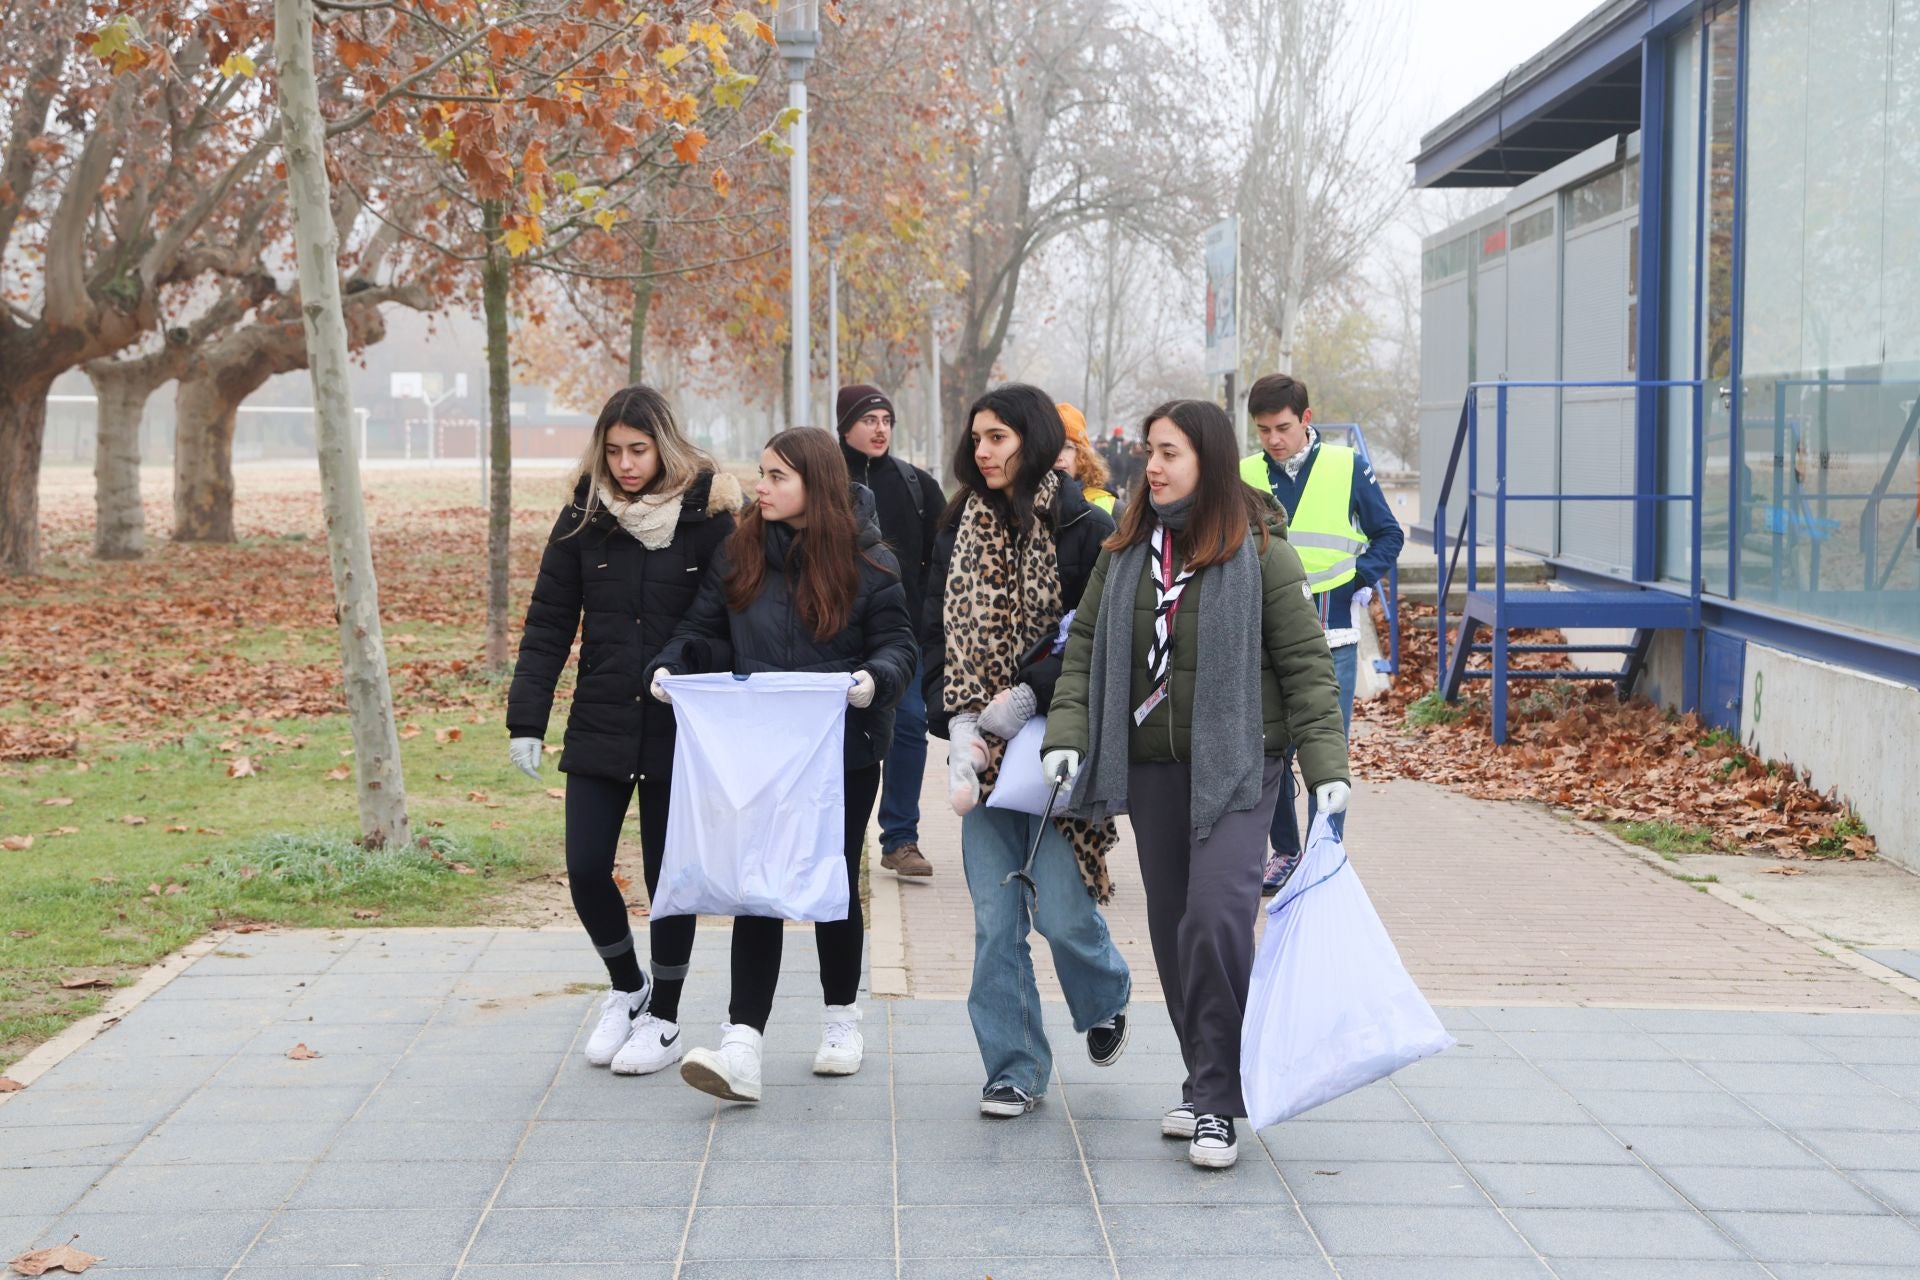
[{"left": 566, "top": 773, "right": 699, "bottom": 1023}]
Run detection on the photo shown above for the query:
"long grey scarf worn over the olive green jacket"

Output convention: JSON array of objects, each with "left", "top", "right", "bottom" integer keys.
[{"left": 1073, "top": 497, "right": 1265, "bottom": 839}]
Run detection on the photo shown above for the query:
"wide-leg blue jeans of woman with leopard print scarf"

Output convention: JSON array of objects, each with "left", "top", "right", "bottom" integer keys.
[{"left": 960, "top": 804, "right": 1133, "bottom": 1098}]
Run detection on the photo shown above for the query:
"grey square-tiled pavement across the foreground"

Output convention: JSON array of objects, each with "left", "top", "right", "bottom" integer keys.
[{"left": 0, "top": 931, "right": 1920, "bottom": 1280}]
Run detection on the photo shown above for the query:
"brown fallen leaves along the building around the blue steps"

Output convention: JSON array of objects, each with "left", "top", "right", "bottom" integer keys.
[{"left": 1352, "top": 604, "right": 1876, "bottom": 858}]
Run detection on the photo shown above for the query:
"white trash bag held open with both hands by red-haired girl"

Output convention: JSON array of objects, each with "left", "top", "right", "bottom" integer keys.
[{"left": 651, "top": 672, "right": 849, "bottom": 921}]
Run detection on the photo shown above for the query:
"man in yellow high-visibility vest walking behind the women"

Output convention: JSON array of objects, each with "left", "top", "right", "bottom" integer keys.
[{"left": 1240, "top": 374, "right": 1407, "bottom": 896}]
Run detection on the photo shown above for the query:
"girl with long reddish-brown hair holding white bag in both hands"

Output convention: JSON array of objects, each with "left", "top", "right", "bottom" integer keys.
[{"left": 653, "top": 428, "right": 918, "bottom": 1102}]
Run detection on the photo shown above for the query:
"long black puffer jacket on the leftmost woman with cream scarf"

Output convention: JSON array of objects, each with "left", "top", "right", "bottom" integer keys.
[{"left": 507, "top": 472, "right": 741, "bottom": 781}]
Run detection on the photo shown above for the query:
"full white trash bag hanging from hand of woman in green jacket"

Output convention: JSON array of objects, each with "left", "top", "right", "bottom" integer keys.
[{"left": 1240, "top": 816, "right": 1453, "bottom": 1128}]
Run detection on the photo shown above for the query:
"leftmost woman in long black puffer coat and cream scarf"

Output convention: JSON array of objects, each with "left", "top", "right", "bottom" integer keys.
[{"left": 507, "top": 386, "right": 741, "bottom": 1075}]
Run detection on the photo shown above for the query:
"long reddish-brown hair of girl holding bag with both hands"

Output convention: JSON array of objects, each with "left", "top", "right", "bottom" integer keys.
[{"left": 726, "top": 426, "right": 874, "bottom": 641}]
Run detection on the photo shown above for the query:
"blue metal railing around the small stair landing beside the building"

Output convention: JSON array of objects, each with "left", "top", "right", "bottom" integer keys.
[{"left": 1434, "top": 378, "right": 1705, "bottom": 681}]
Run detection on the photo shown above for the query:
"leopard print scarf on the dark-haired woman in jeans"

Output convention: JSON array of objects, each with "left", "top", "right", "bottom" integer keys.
[{"left": 943, "top": 472, "right": 1119, "bottom": 904}]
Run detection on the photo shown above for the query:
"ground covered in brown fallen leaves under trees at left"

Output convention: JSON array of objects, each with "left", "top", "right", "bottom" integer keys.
[{"left": 0, "top": 472, "right": 559, "bottom": 762}]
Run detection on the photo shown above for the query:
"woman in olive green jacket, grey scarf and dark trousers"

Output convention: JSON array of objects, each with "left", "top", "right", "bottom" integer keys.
[{"left": 1041, "top": 399, "right": 1348, "bottom": 1169}]
